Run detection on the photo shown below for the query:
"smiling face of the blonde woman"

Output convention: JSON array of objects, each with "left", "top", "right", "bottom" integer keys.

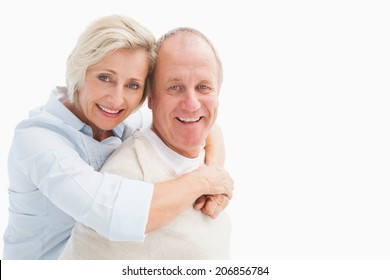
[{"left": 74, "top": 49, "right": 149, "bottom": 141}]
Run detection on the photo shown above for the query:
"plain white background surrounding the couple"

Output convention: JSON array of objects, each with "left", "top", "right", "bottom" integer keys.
[{"left": 0, "top": 0, "right": 390, "bottom": 260}]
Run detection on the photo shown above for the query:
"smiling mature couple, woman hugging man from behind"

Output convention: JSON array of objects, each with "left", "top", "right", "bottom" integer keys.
[{"left": 4, "top": 16, "right": 233, "bottom": 259}]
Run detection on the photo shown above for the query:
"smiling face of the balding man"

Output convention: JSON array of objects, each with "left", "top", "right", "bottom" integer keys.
[{"left": 148, "top": 33, "right": 219, "bottom": 157}]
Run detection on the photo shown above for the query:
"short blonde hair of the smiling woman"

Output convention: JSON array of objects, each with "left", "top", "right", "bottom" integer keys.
[{"left": 66, "top": 15, "right": 156, "bottom": 104}]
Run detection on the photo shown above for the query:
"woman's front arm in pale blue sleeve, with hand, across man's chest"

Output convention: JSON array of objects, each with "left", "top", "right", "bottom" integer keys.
[{"left": 11, "top": 123, "right": 233, "bottom": 241}]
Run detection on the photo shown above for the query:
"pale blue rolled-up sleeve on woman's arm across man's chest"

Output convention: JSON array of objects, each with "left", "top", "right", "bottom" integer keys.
[{"left": 12, "top": 124, "right": 153, "bottom": 241}]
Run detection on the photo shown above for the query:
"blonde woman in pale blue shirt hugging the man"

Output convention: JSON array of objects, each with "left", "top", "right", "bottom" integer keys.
[{"left": 3, "top": 16, "right": 232, "bottom": 259}]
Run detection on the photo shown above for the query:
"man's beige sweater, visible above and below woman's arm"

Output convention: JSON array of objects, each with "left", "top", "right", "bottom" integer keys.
[{"left": 60, "top": 130, "right": 231, "bottom": 260}]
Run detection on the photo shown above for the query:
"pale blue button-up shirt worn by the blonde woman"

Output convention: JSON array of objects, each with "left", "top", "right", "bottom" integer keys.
[{"left": 3, "top": 96, "right": 153, "bottom": 259}]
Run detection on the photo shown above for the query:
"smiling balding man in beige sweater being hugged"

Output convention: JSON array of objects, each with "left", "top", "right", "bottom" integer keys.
[{"left": 62, "top": 28, "right": 230, "bottom": 259}]
